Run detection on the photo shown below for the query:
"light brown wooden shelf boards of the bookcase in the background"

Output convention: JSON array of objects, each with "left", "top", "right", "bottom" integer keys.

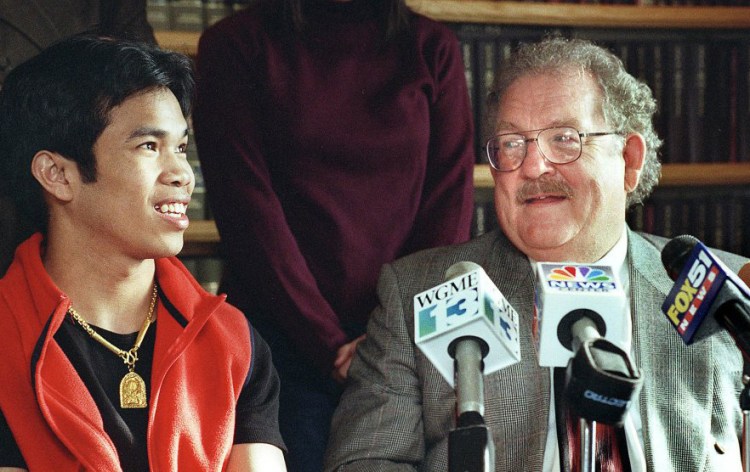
[{"left": 164, "top": 0, "right": 750, "bottom": 256}]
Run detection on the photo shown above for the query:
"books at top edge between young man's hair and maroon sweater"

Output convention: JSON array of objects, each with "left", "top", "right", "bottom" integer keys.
[{"left": 146, "top": 0, "right": 254, "bottom": 31}]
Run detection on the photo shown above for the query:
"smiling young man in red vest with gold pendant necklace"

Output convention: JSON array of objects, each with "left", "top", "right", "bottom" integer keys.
[{"left": 0, "top": 37, "right": 285, "bottom": 471}]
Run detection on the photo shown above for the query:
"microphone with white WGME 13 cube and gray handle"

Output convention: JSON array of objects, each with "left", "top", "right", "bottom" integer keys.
[{"left": 414, "top": 262, "right": 521, "bottom": 472}]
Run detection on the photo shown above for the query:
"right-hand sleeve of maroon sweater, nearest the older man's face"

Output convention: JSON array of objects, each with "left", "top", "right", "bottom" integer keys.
[{"left": 404, "top": 20, "right": 475, "bottom": 254}]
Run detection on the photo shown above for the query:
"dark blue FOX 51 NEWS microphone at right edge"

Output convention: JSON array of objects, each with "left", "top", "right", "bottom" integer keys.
[{"left": 661, "top": 235, "right": 750, "bottom": 359}]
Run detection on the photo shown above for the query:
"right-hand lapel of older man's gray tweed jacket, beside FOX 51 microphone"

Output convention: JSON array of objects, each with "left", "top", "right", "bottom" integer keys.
[{"left": 628, "top": 232, "right": 714, "bottom": 471}]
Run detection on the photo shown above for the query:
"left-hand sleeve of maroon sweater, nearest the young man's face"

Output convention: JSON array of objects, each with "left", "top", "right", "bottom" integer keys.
[{"left": 193, "top": 23, "right": 347, "bottom": 374}]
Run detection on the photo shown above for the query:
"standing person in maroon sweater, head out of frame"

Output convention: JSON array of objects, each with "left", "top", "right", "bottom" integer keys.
[{"left": 193, "top": 0, "right": 474, "bottom": 471}]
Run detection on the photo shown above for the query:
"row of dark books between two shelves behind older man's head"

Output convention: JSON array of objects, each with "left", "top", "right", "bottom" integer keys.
[{"left": 454, "top": 24, "right": 750, "bottom": 163}]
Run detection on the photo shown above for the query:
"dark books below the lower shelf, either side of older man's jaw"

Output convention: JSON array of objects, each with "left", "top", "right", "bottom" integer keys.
[{"left": 472, "top": 186, "right": 750, "bottom": 257}]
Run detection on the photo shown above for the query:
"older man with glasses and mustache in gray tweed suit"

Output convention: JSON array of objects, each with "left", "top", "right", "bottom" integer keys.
[{"left": 326, "top": 35, "right": 746, "bottom": 472}]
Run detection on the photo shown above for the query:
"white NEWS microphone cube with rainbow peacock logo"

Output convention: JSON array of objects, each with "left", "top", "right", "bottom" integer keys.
[{"left": 532, "top": 262, "right": 630, "bottom": 367}]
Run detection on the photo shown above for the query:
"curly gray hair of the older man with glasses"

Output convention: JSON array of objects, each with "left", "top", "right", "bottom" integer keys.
[{"left": 487, "top": 36, "right": 662, "bottom": 207}]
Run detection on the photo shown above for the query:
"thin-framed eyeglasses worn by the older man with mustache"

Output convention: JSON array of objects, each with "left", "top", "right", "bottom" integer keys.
[{"left": 485, "top": 126, "right": 621, "bottom": 172}]
